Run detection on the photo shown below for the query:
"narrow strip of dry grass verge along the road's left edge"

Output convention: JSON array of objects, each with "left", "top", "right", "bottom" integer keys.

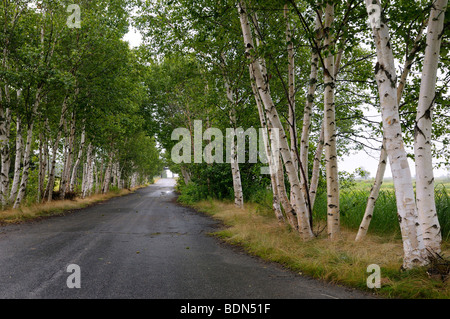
[{"left": 0, "top": 186, "right": 145, "bottom": 225}]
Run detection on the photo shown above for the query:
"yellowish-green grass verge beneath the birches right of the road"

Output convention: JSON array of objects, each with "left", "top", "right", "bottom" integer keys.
[{"left": 191, "top": 200, "right": 450, "bottom": 298}]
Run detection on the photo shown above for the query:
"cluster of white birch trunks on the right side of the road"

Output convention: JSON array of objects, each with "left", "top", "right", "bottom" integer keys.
[{"left": 227, "top": 0, "right": 447, "bottom": 268}]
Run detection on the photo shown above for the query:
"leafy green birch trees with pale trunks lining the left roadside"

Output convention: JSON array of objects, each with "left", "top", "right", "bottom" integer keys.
[{"left": 0, "top": 1, "right": 153, "bottom": 212}]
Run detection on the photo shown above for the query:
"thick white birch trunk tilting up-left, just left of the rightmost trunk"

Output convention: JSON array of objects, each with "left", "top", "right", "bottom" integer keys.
[{"left": 365, "top": 0, "right": 427, "bottom": 269}]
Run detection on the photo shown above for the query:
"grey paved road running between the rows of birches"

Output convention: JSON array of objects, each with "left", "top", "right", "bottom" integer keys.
[{"left": 0, "top": 179, "right": 367, "bottom": 299}]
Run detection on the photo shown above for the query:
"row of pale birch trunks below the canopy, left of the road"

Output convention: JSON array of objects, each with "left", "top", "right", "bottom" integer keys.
[{"left": 0, "top": 90, "right": 148, "bottom": 208}]
